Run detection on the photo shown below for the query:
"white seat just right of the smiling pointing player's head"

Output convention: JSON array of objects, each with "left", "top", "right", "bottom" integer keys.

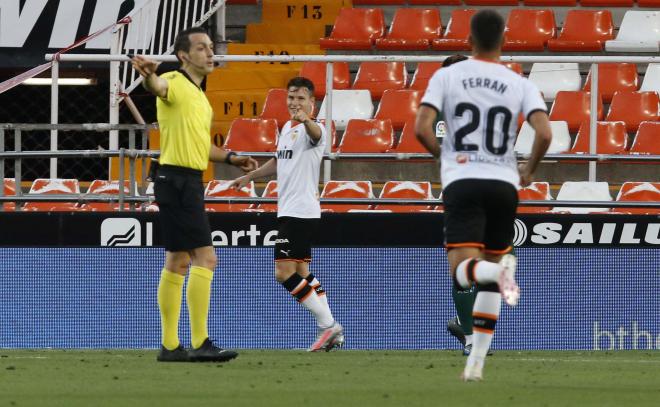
[{"left": 317, "top": 90, "right": 374, "bottom": 130}]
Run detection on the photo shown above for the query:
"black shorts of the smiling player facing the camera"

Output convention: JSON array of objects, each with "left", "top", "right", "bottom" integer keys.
[{"left": 275, "top": 216, "right": 319, "bottom": 263}]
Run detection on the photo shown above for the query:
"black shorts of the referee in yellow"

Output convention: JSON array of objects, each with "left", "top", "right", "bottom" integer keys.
[{"left": 154, "top": 165, "right": 211, "bottom": 252}]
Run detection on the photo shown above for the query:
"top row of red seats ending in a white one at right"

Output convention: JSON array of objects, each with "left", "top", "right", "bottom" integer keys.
[{"left": 319, "top": 8, "right": 660, "bottom": 52}]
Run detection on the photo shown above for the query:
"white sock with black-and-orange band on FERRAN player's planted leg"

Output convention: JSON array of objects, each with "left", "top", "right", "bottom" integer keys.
[{"left": 467, "top": 292, "right": 502, "bottom": 366}]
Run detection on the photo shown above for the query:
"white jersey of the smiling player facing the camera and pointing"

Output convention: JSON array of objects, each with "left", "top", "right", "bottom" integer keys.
[{"left": 277, "top": 121, "right": 326, "bottom": 218}]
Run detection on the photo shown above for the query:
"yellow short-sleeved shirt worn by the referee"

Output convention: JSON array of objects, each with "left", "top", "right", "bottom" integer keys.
[{"left": 156, "top": 71, "right": 213, "bottom": 171}]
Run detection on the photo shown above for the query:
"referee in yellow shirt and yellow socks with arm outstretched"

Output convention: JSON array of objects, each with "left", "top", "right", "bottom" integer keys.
[{"left": 132, "top": 27, "right": 257, "bottom": 362}]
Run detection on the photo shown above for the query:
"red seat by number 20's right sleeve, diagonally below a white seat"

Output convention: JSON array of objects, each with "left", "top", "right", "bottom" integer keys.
[{"left": 550, "top": 91, "right": 603, "bottom": 132}]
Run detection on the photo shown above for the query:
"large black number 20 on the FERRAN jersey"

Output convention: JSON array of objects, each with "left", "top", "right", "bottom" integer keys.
[{"left": 454, "top": 103, "right": 513, "bottom": 155}]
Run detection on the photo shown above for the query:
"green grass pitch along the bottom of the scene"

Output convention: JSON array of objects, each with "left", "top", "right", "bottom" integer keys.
[{"left": 0, "top": 349, "right": 660, "bottom": 407}]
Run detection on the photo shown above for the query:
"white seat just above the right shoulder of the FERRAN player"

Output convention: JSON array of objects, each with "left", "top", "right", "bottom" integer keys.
[{"left": 528, "top": 62, "right": 582, "bottom": 102}]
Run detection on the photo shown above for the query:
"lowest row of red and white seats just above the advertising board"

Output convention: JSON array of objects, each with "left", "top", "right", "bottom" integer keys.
[{"left": 4, "top": 178, "right": 660, "bottom": 214}]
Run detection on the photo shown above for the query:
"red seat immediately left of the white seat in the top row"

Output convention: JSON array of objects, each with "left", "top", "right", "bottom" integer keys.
[{"left": 548, "top": 9, "right": 614, "bottom": 52}]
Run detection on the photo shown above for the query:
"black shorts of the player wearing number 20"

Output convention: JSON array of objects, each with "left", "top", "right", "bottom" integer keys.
[{"left": 442, "top": 179, "right": 518, "bottom": 254}]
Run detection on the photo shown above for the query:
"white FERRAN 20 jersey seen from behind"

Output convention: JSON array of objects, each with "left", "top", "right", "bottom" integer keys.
[{"left": 422, "top": 59, "right": 547, "bottom": 188}]
